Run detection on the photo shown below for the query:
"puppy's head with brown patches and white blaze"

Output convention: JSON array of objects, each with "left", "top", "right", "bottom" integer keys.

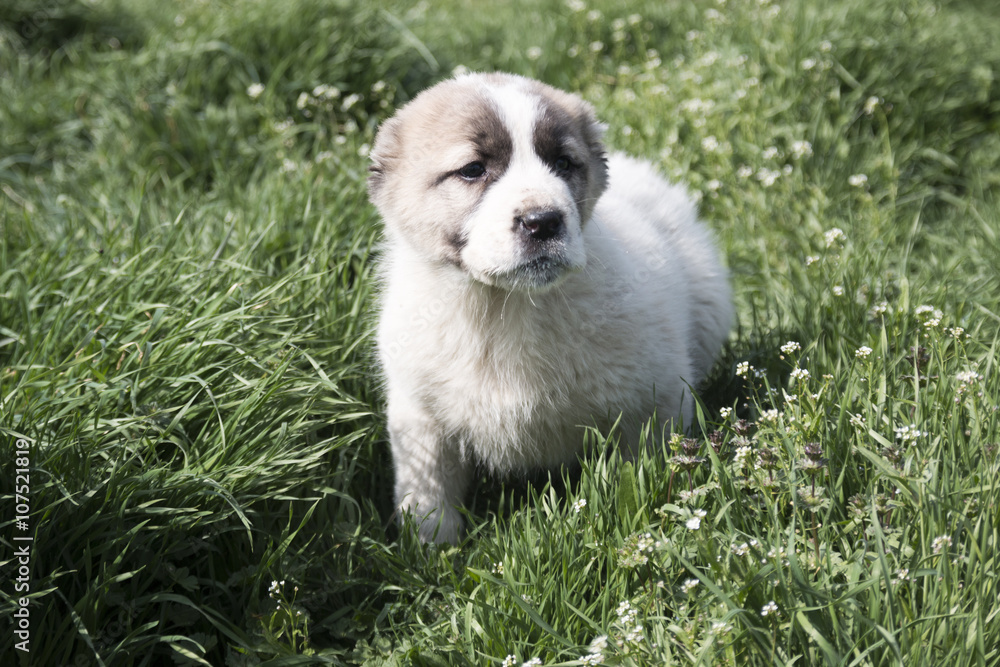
[{"left": 368, "top": 74, "right": 607, "bottom": 290}]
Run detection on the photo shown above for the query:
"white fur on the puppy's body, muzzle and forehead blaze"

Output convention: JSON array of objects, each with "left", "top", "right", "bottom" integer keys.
[{"left": 376, "top": 74, "right": 731, "bottom": 541}]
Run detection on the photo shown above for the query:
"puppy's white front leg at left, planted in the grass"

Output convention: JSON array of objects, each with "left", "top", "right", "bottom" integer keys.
[{"left": 389, "top": 411, "right": 472, "bottom": 543}]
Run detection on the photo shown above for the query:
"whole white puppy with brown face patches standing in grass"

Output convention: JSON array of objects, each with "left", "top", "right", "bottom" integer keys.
[{"left": 369, "top": 74, "right": 732, "bottom": 541}]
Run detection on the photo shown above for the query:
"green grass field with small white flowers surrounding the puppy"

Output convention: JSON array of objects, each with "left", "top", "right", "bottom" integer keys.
[{"left": 0, "top": 0, "right": 1000, "bottom": 667}]
